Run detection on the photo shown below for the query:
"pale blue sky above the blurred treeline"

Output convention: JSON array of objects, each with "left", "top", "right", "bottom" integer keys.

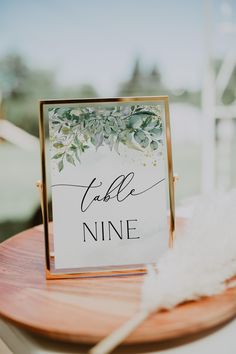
[{"left": 0, "top": 0, "right": 236, "bottom": 96}]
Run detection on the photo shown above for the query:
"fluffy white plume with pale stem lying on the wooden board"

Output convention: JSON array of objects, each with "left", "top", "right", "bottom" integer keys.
[{"left": 90, "top": 191, "right": 236, "bottom": 354}]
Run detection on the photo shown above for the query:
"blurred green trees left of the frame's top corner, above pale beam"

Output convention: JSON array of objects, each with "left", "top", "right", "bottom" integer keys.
[{"left": 0, "top": 54, "right": 97, "bottom": 136}]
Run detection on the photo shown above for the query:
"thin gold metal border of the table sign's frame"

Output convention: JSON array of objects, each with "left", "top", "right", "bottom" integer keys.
[{"left": 38, "top": 96, "right": 175, "bottom": 279}]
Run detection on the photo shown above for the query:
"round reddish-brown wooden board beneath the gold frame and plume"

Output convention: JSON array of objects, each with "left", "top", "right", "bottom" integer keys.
[{"left": 0, "top": 221, "right": 236, "bottom": 344}]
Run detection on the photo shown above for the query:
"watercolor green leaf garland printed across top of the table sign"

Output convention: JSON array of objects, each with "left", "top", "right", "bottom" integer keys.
[{"left": 49, "top": 105, "right": 163, "bottom": 172}]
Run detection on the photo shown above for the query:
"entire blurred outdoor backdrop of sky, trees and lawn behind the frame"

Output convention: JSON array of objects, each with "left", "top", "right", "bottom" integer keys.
[{"left": 0, "top": 0, "right": 236, "bottom": 241}]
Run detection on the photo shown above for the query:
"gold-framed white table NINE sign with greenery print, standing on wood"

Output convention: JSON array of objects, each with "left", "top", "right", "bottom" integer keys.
[{"left": 40, "top": 96, "right": 174, "bottom": 279}]
